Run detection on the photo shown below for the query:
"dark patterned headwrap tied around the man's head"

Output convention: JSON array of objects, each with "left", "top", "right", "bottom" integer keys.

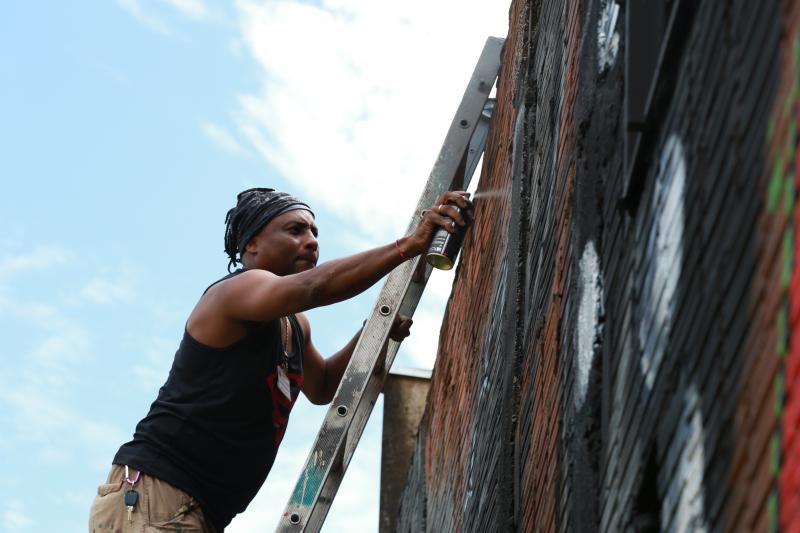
[{"left": 225, "top": 187, "right": 314, "bottom": 272}]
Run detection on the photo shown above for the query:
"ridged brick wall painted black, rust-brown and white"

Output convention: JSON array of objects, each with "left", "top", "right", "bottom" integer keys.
[{"left": 398, "top": 0, "right": 800, "bottom": 532}]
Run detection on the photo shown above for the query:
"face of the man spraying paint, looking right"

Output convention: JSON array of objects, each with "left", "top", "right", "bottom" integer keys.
[{"left": 246, "top": 209, "right": 319, "bottom": 276}]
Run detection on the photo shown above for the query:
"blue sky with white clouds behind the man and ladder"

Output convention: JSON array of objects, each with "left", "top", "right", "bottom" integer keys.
[{"left": 0, "top": 0, "right": 508, "bottom": 533}]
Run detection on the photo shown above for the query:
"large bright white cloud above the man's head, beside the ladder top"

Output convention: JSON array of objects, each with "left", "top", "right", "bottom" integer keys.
[{"left": 235, "top": 0, "right": 508, "bottom": 239}]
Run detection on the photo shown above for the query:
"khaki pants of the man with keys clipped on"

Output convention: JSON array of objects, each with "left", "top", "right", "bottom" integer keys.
[{"left": 89, "top": 465, "right": 214, "bottom": 533}]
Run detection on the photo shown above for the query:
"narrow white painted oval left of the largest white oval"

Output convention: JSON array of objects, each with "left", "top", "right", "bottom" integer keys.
[{"left": 573, "top": 241, "right": 603, "bottom": 411}]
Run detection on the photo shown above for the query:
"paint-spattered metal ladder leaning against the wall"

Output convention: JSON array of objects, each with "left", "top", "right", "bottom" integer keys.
[{"left": 276, "top": 37, "right": 504, "bottom": 532}]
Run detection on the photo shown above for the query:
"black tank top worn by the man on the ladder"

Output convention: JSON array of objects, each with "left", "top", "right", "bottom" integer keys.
[{"left": 114, "top": 271, "right": 303, "bottom": 533}]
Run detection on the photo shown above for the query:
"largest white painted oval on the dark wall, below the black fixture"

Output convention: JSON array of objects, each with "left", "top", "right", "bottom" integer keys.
[{"left": 639, "top": 134, "right": 686, "bottom": 389}]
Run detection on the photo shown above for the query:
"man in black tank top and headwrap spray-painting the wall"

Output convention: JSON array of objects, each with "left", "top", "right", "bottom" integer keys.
[{"left": 89, "top": 188, "right": 471, "bottom": 533}]
